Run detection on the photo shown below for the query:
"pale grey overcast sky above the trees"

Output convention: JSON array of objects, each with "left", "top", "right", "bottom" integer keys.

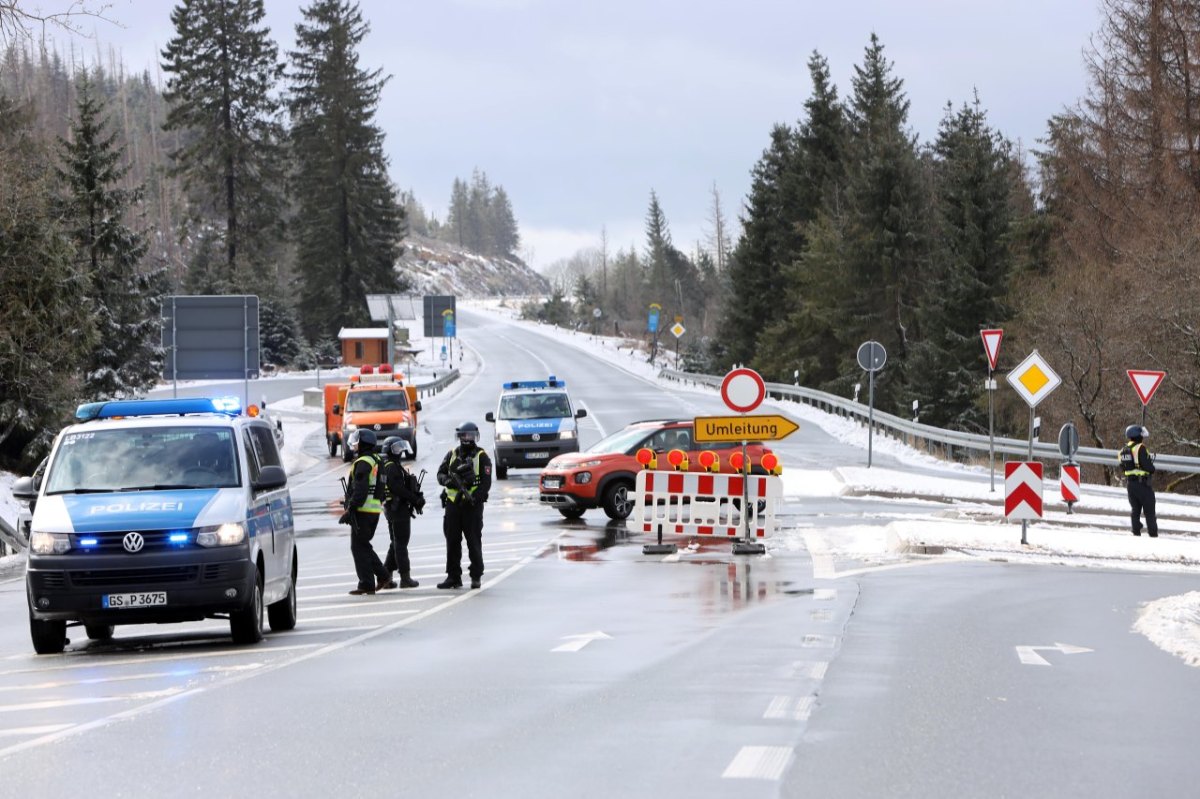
[{"left": 60, "top": 0, "right": 1099, "bottom": 268}]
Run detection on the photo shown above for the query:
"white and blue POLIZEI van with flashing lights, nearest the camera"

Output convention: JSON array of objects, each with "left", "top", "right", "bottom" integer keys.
[{"left": 13, "top": 398, "right": 298, "bottom": 654}]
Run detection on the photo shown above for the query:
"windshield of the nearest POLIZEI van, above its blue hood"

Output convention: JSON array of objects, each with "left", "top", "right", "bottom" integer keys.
[{"left": 46, "top": 426, "right": 240, "bottom": 494}]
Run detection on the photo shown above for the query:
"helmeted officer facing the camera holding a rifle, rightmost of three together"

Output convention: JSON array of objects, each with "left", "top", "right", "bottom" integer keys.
[{"left": 438, "top": 422, "right": 492, "bottom": 588}]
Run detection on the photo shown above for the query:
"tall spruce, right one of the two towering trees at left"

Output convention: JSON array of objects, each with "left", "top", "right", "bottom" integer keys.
[{"left": 289, "top": 0, "right": 406, "bottom": 341}]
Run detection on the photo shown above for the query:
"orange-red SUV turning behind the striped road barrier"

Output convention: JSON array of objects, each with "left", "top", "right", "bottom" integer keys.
[{"left": 538, "top": 419, "right": 768, "bottom": 519}]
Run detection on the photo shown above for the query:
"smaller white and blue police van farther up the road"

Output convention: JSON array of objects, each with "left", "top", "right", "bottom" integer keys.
[{"left": 486, "top": 374, "right": 588, "bottom": 480}]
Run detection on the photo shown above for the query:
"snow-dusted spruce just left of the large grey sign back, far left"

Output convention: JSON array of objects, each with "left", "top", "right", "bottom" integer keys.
[{"left": 59, "top": 76, "right": 166, "bottom": 400}]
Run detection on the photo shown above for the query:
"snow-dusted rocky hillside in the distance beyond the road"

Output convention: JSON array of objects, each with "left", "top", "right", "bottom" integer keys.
[{"left": 398, "top": 234, "right": 550, "bottom": 298}]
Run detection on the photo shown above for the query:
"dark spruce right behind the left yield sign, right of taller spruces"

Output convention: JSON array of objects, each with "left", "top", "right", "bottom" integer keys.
[{"left": 910, "top": 97, "right": 1014, "bottom": 431}]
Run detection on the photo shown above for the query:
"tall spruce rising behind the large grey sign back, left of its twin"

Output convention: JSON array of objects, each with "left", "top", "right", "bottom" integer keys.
[{"left": 162, "top": 0, "right": 284, "bottom": 292}]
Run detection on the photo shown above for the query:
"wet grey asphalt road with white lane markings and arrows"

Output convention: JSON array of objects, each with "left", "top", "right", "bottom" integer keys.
[{"left": 0, "top": 308, "right": 1200, "bottom": 799}]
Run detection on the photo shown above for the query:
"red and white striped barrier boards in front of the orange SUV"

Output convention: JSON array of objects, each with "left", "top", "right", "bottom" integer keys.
[{"left": 629, "top": 469, "right": 784, "bottom": 539}]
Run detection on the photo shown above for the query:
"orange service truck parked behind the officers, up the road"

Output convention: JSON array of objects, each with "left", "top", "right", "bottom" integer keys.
[{"left": 325, "top": 367, "right": 421, "bottom": 462}]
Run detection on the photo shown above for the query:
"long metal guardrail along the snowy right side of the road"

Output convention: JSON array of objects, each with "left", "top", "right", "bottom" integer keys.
[{"left": 659, "top": 370, "right": 1200, "bottom": 474}]
